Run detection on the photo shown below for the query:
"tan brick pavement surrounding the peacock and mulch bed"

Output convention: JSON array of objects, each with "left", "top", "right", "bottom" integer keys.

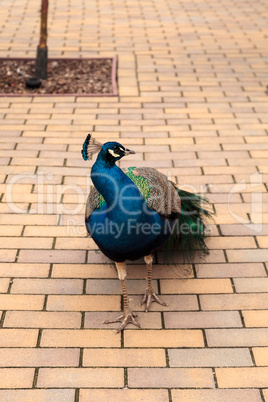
[{"left": 0, "top": 0, "right": 268, "bottom": 402}]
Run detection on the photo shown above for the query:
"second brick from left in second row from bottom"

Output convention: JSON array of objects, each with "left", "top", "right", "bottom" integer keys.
[{"left": 37, "top": 368, "right": 124, "bottom": 388}]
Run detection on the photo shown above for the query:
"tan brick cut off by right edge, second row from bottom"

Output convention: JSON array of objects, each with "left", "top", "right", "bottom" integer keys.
[{"left": 216, "top": 367, "right": 268, "bottom": 388}]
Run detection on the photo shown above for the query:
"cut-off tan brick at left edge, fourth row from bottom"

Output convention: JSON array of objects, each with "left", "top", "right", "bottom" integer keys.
[{"left": 0, "top": 328, "right": 38, "bottom": 348}]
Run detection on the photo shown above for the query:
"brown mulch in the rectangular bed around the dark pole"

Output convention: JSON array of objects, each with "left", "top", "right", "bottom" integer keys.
[{"left": 0, "top": 59, "right": 113, "bottom": 94}]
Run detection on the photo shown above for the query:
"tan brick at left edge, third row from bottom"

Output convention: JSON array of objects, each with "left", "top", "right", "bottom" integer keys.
[{"left": 0, "top": 348, "right": 80, "bottom": 367}]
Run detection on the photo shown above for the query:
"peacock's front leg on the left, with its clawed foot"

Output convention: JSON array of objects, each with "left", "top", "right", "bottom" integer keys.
[{"left": 104, "top": 262, "right": 141, "bottom": 333}]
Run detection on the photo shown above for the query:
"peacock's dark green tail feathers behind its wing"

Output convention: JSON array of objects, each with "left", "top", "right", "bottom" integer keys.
[{"left": 163, "top": 188, "right": 213, "bottom": 263}]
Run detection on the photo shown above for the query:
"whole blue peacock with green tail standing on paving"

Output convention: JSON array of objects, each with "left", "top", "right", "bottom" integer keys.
[{"left": 81, "top": 134, "right": 210, "bottom": 333}]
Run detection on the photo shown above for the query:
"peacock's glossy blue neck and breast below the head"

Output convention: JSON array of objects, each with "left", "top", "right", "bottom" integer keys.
[{"left": 86, "top": 155, "right": 173, "bottom": 262}]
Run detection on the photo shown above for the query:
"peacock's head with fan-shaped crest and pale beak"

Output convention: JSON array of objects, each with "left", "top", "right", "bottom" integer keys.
[{"left": 81, "top": 134, "right": 135, "bottom": 164}]
